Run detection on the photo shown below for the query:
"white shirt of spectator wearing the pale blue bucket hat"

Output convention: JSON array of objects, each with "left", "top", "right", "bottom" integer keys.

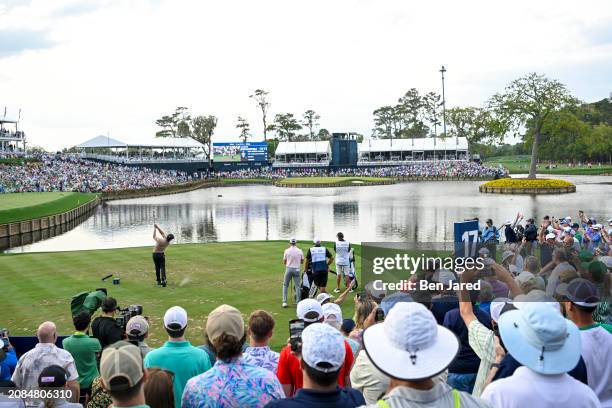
[{"left": 481, "top": 366, "right": 601, "bottom": 408}]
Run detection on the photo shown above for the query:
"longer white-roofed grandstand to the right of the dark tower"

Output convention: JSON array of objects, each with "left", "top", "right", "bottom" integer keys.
[{"left": 357, "top": 137, "right": 469, "bottom": 166}]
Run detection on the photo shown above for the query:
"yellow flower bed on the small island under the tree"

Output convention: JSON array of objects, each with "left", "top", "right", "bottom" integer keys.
[{"left": 479, "top": 178, "right": 576, "bottom": 194}]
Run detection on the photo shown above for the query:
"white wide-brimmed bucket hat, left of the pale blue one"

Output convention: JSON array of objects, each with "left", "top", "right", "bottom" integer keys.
[{"left": 363, "top": 302, "right": 459, "bottom": 380}]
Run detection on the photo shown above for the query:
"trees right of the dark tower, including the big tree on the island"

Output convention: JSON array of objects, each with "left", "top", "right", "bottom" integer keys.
[{"left": 372, "top": 73, "right": 612, "bottom": 178}]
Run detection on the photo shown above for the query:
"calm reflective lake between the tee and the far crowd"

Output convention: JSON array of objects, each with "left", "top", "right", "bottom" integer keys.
[{"left": 6, "top": 176, "right": 612, "bottom": 252}]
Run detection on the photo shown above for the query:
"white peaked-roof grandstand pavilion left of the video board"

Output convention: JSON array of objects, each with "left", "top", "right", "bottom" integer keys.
[{"left": 75, "top": 136, "right": 207, "bottom": 164}]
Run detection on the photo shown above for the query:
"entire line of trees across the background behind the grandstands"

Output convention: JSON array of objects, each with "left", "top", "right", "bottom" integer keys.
[{"left": 155, "top": 73, "right": 612, "bottom": 178}]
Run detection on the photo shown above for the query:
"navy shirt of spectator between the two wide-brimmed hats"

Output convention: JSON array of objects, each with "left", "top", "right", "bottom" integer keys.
[{"left": 444, "top": 305, "right": 491, "bottom": 374}]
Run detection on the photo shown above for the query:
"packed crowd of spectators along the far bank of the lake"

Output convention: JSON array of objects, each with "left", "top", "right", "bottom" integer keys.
[{"left": 0, "top": 153, "right": 507, "bottom": 193}]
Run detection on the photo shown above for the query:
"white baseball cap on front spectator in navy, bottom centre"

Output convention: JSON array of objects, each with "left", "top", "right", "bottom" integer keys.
[{"left": 302, "top": 323, "right": 346, "bottom": 373}]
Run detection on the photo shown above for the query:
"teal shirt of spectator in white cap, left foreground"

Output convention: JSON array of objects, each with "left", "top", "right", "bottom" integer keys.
[{"left": 144, "top": 340, "right": 211, "bottom": 408}]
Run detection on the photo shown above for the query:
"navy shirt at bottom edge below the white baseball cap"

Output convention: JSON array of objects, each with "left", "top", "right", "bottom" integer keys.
[{"left": 266, "top": 387, "right": 365, "bottom": 408}]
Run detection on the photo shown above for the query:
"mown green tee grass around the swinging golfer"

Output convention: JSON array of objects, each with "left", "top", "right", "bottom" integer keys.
[{"left": 0, "top": 241, "right": 361, "bottom": 350}]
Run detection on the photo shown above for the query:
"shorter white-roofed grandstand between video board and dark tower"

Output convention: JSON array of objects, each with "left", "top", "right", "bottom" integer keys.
[{"left": 272, "top": 141, "right": 332, "bottom": 167}]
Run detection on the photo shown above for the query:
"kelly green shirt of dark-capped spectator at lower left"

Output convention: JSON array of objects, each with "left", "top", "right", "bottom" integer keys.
[{"left": 62, "top": 332, "right": 102, "bottom": 388}]
